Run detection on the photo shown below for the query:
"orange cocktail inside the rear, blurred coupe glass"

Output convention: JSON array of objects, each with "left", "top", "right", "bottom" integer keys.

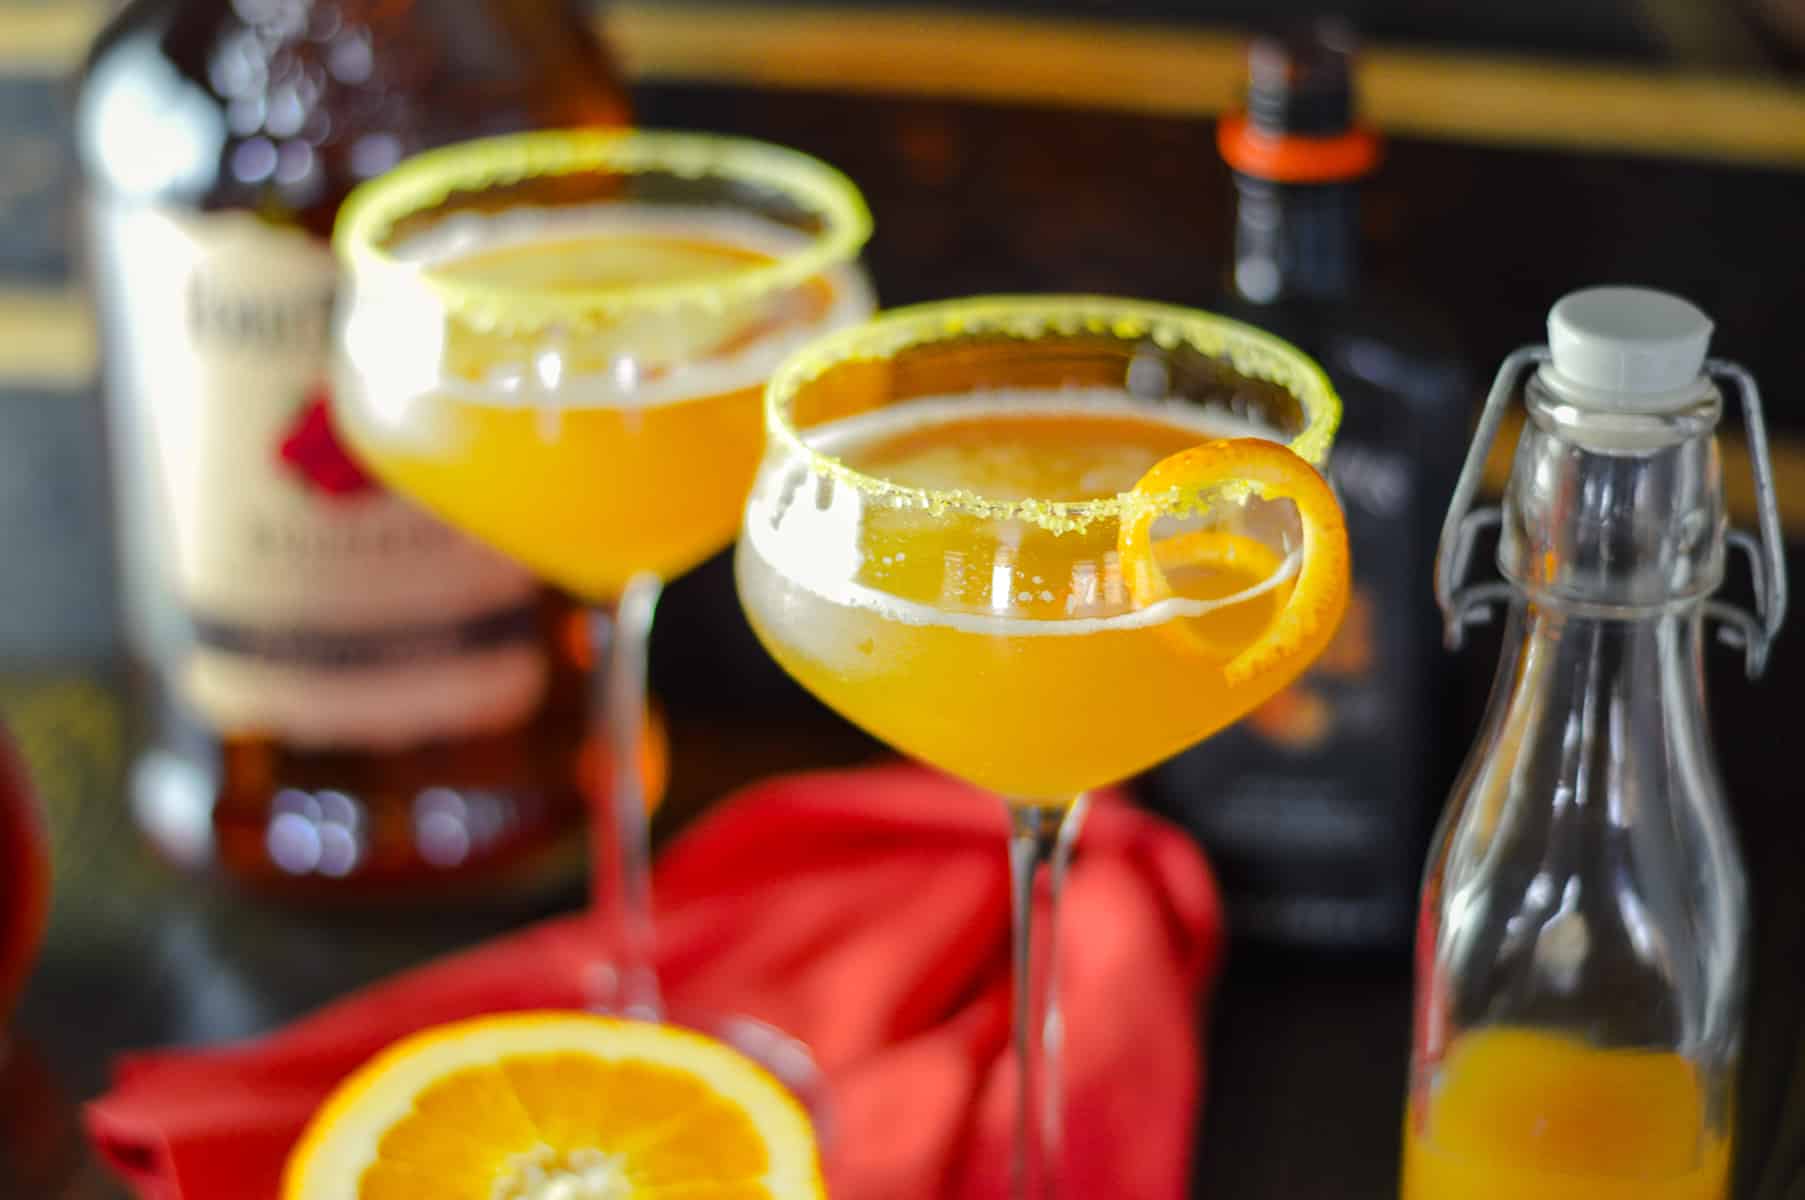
[{"left": 338, "top": 204, "right": 872, "bottom": 599}]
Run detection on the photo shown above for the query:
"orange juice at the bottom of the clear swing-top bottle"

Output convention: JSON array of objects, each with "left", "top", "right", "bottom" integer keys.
[{"left": 1402, "top": 1029, "right": 1729, "bottom": 1200}]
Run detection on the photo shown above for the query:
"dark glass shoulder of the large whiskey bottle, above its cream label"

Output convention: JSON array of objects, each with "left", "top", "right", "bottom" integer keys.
[{"left": 74, "top": 0, "right": 626, "bottom": 221}]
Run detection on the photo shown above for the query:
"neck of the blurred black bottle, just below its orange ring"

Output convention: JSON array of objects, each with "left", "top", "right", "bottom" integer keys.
[{"left": 1235, "top": 171, "right": 1359, "bottom": 305}]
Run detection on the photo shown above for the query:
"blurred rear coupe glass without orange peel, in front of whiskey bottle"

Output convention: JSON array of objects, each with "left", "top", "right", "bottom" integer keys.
[{"left": 334, "top": 130, "right": 872, "bottom": 1032}]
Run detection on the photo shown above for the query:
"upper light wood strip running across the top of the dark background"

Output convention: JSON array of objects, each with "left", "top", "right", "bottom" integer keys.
[{"left": 10, "top": 0, "right": 1805, "bottom": 166}]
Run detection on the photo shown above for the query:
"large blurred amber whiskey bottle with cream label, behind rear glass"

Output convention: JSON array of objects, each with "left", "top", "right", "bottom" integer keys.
[{"left": 76, "top": 0, "right": 628, "bottom": 902}]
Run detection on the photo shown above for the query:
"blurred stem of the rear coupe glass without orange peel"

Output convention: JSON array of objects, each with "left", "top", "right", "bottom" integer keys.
[{"left": 587, "top": 574, "right": 664, "bottom": 1021}]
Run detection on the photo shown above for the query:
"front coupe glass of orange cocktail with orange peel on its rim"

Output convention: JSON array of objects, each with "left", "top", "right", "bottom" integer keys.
[{"left": 736, "top": 296, "right": 1348, "bottom": 1198}]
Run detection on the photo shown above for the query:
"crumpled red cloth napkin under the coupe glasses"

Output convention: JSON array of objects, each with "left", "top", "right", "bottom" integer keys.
[{"left": 87, "top": 765, "right": 1222, "bottom": 1200}]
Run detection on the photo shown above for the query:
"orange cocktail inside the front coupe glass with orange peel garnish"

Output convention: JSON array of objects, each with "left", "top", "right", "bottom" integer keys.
[{"left": 740, "top": 390, "right": 1321, "bottom": 799}]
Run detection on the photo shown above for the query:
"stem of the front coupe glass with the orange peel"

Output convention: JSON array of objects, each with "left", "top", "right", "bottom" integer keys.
[{"left": 1009, "top": 796, "right": 1085, "bottom": 1200}]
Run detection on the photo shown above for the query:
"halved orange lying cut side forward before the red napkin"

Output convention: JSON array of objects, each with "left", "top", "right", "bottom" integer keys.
[{"left": 282, "top": 1012, "right": 825, "bottom": 1200}]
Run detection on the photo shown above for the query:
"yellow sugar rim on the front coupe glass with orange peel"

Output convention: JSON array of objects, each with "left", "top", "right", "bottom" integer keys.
[{"left": 765, "top": 296, "right": 1341, "bottom": 532}]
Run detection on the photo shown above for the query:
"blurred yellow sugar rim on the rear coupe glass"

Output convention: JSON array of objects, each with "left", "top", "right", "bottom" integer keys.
[{"left": 332, "top": 130, "right": 872, "bottom": 334}]
